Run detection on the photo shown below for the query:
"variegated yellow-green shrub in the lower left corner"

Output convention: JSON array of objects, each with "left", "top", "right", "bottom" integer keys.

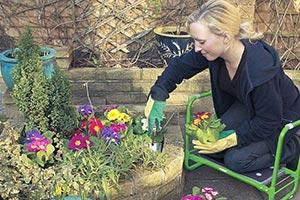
[{"left": 0, "top": 123, "right": 57, "bottom": 199}]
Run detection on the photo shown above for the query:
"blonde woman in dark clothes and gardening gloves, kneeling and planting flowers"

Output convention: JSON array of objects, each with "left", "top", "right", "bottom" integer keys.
[{"left": 145, "top": 0, "right": 300, "bottom": 172}]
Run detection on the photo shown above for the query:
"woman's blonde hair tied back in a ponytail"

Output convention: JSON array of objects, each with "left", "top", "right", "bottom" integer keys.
[{"left": 186, "top": 0, "right": 263, "bottom": 40}]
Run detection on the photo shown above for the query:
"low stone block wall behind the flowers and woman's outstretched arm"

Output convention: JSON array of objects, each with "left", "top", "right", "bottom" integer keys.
[{"left": 67, "top": 68, "right": 300, "bottom": 112}]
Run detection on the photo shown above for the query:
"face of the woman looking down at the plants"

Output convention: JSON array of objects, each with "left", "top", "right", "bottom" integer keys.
[{"left": 190, "top": 22, "right": 227, "bottom": 61}]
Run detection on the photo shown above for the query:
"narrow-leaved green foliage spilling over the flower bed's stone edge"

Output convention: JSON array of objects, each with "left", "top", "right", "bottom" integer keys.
[{"left": 52, "top": 134, "right": 166, "bottom": 199}]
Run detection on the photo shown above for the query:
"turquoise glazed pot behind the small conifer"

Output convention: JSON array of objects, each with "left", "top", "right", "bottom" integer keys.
[{"left": 0, "top": 47, "right": 56, "bottom": 91}]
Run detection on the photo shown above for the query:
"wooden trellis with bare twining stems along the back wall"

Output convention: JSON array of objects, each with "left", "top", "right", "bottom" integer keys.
[{"left": 0, "top": 0, "right": 300, "bottom": 69}]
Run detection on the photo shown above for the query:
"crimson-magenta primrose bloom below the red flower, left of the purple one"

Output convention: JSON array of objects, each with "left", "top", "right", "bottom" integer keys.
[{"left": 68, "top": 131, "right": 93, "bottom": 150}]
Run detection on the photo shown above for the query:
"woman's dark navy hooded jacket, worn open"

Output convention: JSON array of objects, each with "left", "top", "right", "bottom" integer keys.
[{"left": 150, "top": 40, "right": 300, "bottom": 153}]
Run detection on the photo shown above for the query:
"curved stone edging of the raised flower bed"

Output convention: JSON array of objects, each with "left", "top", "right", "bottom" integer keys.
[{"left": 112, "top": 125, "right": 184, "bottom": 200}]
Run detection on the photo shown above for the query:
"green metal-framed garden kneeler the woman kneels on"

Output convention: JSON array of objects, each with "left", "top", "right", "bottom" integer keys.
[{"left": 184, "top": 91, "right": 300, "bottom": 200}]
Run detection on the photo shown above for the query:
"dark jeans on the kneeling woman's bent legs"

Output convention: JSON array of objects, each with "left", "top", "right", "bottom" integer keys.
[{"left": 211, "top": 102, "right": 299, "bottom": 173}]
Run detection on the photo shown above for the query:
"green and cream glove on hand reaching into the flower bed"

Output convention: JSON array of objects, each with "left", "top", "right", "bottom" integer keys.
[{"left": 144, "top": 96, "right": 166, "bottom": 135}]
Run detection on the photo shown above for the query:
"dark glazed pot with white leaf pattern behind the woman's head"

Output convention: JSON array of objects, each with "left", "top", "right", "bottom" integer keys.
[{"left": 154, "top": 26, "right": 194, "bottom": 65}]
